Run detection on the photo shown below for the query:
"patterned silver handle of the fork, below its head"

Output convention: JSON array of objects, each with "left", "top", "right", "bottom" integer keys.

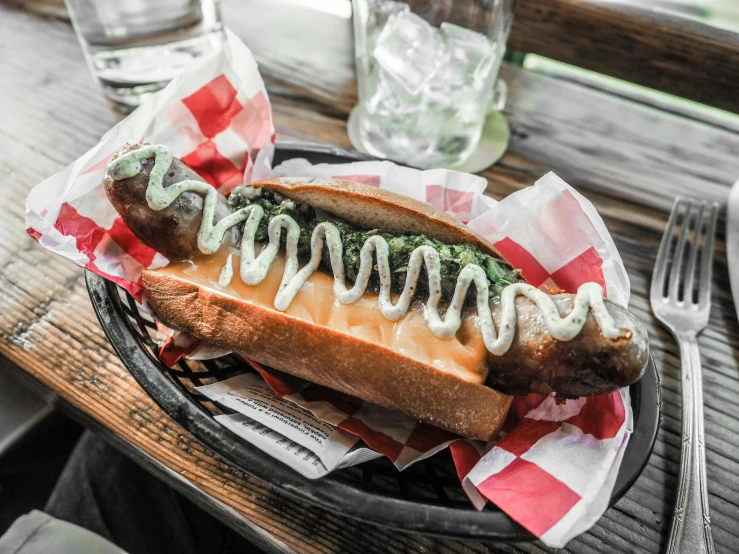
[{"left": 666, "top": 333, "right": 714, "bottom": 554}]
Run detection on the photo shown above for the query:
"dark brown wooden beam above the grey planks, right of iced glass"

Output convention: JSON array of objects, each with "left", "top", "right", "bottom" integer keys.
[{"left": 508, "top": 0, "right": 739, "bottom": 113}]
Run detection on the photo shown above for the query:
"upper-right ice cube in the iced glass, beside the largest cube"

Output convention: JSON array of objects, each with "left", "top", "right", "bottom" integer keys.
[{"left": 441, "top": 22, "right": 497, "bottom": 86}]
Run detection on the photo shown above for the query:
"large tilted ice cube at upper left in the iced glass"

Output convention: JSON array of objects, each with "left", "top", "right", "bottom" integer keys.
[{"left": 372, "top": 12, "right": 449, "bottom": 95}]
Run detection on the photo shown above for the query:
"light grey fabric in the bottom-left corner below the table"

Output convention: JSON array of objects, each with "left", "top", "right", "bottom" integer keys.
[{"left": 0, "top": 510, "right": 126, "bottom": 554}]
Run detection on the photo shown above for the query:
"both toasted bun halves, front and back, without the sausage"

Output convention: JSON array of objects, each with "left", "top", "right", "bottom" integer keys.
[{"left": 143, "top": 178, "right": 511, "bottom": 441}]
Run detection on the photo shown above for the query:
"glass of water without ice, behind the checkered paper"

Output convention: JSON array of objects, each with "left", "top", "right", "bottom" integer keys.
[{"left": 65, "top": 0, "right": 225, "bottom": 111}]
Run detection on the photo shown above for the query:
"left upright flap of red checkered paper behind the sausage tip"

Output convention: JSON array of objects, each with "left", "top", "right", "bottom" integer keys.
[{"left": 26, "top": 28, "right": 275, "bottom": 299}]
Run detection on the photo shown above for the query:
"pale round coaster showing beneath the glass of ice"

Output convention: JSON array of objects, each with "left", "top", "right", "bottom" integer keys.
[{"left": 347, "top": 106, "right": 511, "bottom": 173}]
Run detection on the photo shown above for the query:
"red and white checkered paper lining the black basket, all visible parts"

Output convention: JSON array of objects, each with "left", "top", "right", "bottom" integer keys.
[{"left": 26, "top": 29, "right": 632, "bottom": 547}]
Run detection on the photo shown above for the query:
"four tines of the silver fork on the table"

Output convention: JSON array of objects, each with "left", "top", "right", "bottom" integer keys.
[{"left": 650, "top": 197, "right": 718, "bottom": 309}]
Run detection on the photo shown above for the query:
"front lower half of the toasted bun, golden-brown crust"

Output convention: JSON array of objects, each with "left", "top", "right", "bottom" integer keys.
[{"left": 143, "top": 270, "right": 511, "bottom": 441}]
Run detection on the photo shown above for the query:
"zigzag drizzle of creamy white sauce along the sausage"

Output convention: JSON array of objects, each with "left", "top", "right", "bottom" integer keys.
[{"left": 108, "top": 145, "right": 627, "bottom": 356}]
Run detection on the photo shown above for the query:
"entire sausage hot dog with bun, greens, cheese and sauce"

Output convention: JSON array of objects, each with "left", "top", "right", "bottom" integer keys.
[{"left": 104, "top": 145, "right": 648, "bottom": 440}]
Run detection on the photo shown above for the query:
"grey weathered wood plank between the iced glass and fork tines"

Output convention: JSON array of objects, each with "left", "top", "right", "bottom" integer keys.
[{"left": 505, "top": 71, "right": 739, "bottom": 212}]
